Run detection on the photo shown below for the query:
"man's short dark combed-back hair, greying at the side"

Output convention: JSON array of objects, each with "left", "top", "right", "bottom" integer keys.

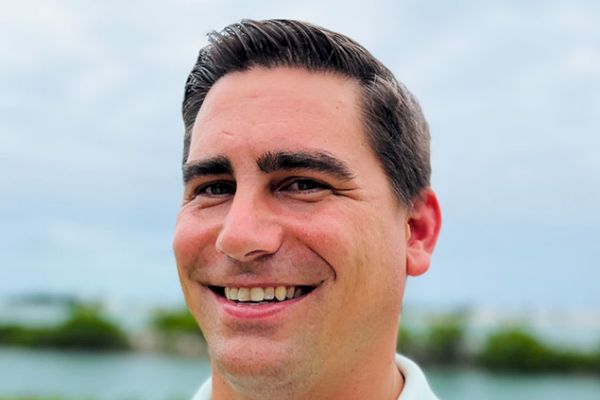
[{"left": 182, "top": 19, "right": 431, "bottom": 205}]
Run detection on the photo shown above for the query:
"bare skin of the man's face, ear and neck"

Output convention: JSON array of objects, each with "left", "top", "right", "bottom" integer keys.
[{"left": 173, "top": 68, "right": 441, "bottom": 400}]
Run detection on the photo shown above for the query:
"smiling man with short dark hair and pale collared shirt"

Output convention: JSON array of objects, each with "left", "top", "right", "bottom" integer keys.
[{"left": 173, "top": 20, "right": 441, "bottom": 400}]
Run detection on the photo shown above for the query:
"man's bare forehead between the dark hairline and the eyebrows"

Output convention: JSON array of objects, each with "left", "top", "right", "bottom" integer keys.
[{"left": 190, "top": 68, "right": 362, "bottom": 155}]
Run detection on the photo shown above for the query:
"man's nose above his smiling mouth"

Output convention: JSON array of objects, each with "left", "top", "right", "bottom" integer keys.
[{"left": 216, "top": 191, "right": 283, "bottom": 262}]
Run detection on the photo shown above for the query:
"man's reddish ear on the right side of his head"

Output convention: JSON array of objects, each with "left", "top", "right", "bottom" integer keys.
[{"left": 406, "top": 188, "right": 442, "bottom": 276}]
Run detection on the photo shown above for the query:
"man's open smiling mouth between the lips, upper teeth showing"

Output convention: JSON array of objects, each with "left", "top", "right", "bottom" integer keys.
[{"left": 209, "top": 286, "right": 316, "bottom": 305}]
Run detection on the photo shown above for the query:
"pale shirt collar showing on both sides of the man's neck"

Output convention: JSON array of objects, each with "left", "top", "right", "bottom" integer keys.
[{"left": 192, "top": 354, "right": 438, "bottom": 400}]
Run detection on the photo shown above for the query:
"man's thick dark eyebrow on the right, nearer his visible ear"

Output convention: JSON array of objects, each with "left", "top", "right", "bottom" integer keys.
[{"left": 256, "top": 151, "right": 354, "bottom": 180}]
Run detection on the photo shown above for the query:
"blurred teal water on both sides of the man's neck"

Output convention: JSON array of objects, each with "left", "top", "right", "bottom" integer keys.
[{"left": 0, "top": 348, "right": 600, "bottom": 400}]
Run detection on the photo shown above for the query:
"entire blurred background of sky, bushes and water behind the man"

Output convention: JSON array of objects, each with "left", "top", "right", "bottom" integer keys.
[{"left": 0, "top": 0, "right": 600, "bottom": 400}]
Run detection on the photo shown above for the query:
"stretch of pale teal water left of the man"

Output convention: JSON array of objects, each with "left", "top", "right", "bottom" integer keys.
[{"left": 0, "top": 348, "right": 210, "bottom": 400}]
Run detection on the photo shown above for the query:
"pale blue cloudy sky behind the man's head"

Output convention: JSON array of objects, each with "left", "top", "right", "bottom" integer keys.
[{"left": 0, "top": 0, "right": 600, "bottom": 308}]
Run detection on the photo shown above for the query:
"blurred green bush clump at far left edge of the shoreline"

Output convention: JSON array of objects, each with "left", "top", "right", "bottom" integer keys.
[{"left": 0, "top": 304, "right": 129, "bottom": 350}]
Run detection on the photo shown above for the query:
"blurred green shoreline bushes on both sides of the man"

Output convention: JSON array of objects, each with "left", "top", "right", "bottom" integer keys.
[{"left": 0, "top": 303, "right": 600, "bottom": 376}]
